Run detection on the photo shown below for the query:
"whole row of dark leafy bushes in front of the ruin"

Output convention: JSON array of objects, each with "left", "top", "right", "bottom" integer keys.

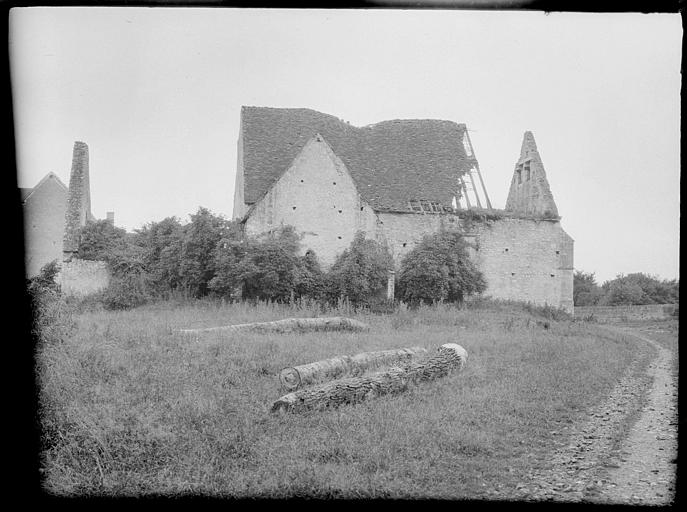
[{"left": 72, "top": 207, "right": 486, "bottom": 309}]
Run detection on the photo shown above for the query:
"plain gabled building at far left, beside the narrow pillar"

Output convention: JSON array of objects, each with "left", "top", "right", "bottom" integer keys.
[{"left": 23, "top": 173, "right": 68, "bottom": 277}]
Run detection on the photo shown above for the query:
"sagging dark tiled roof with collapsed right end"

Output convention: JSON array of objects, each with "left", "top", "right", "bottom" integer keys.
[{"left": 241, "top": 106, "right": 474, "bottom": 211}]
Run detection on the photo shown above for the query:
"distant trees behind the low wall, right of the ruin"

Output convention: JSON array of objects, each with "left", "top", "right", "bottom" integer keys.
[{"left": 573, "top": 271, "right": 680, "bottom": 306}]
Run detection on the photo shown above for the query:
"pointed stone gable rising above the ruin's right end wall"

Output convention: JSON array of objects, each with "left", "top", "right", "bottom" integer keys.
[{"left": 506, "top": 132, "right": 558, "bottom": 218}]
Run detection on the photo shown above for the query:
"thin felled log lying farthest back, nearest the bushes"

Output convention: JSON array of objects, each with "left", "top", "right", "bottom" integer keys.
[{"left": 176, "top": 316, "right": 369, "bottom": 334}]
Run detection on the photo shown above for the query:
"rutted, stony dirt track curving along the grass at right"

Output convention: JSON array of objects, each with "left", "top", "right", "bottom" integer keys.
[{"left": 511, "top": 326, "right": 678, "bottom": 505}]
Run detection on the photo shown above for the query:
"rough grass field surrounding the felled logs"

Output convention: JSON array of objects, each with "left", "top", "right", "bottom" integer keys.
[{"left": 37, "top": 302, "right": 645, "bottom": 499}]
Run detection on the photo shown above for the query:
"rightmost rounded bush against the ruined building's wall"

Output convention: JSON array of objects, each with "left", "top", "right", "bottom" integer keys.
[{"left": 398, "top": 232, "right": 487, "bottom": 304}]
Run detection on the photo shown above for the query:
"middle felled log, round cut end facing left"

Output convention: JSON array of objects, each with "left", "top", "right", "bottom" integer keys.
[{"left": 279, "top": 347, "right": 427, "bottom": 391}]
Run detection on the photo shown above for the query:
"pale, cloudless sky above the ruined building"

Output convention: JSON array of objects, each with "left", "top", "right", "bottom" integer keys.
[{"left": 9, "top": 7, "right": 682, "bottom": 284}]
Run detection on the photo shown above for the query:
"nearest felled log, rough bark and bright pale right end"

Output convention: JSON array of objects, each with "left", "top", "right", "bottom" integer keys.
[{"left": 272, "top": 343, "right": 468, "bottom": 412}]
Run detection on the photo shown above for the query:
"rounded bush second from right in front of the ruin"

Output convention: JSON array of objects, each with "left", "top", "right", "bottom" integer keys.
[{"left": 326, "top": 231, "right": 393, "bottom": 305}]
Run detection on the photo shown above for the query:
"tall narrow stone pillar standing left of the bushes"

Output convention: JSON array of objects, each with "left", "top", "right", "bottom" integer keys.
[{"left": 62, "top": 141, "right": 94, "bottom": 261}]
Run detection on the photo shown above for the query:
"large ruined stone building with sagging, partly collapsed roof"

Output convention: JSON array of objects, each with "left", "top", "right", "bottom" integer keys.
[{"left": 233, "top": 107, "right": 573, "bottom": 312}]
